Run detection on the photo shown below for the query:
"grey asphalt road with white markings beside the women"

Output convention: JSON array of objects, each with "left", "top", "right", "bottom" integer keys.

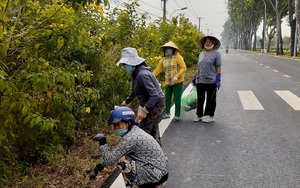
[{"left": 111, "top": 49, "right": 300, "bottom": 188}]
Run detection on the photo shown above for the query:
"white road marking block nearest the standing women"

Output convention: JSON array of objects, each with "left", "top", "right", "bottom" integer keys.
[{"left": 238, "top": 91, "right": 264, "bottom": 110}]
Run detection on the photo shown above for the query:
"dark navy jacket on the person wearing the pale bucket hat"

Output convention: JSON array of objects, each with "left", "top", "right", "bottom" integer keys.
[{"left": 125, "top": 65, "right": 165, "bottom": 111}]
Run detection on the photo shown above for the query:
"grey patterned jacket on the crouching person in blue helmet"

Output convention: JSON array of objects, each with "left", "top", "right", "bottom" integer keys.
[{"left": 100, "top": 125, "right": 168, "bottom": 185}]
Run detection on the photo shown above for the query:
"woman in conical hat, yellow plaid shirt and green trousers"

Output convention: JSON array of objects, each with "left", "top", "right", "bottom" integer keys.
[{"left": 153, "top": 41, "right": 186, "bottom": 121}]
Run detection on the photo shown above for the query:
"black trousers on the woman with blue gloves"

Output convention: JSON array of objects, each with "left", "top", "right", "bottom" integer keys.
[{"left": 196, "top": 83, "right": 218, "bottom": 117}]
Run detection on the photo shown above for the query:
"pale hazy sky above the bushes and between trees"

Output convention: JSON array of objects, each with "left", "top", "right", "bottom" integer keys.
[{"left": 110, "top": 0, "right": 289, "bottom": 38}]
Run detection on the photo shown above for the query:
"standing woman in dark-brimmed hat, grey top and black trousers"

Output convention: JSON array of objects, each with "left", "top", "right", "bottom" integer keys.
[{"left": 193, "top": 36, "right": 222, "bottom": 123}]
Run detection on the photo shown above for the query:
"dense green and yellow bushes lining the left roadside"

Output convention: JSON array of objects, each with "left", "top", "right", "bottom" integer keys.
[{"left": 0, "top": 0, "right": 202, "bottom": 188}]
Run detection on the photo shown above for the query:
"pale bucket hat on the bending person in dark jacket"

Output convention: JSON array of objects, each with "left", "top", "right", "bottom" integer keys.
[{"left": 116, "top": 47, "right": 145, "bottom": 66}]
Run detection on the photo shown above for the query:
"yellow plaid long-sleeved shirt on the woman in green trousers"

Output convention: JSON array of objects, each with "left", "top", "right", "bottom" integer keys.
[{"left": 153, "top": 51, "right": 187, "bottom": 85}]
